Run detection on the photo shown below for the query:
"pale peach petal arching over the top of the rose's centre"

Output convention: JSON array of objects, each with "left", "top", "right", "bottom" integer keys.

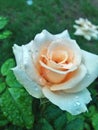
[{"left": 47, "top": 39, "right": 81, "bottom": 66}]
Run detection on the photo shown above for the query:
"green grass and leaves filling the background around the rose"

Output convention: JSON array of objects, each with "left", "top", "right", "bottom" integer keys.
[{"left": 0, "top": 0, "right": 98, "bottom": 130}]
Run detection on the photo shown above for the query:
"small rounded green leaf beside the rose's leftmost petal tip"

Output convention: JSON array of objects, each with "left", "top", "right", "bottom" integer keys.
[{"left": 1, "top": 59, "right": 15, "bottom": 76}]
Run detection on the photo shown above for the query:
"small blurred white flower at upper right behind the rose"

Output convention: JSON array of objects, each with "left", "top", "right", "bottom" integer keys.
[{"left": 73, "top": 18, "right": 98, "bottom": 40}]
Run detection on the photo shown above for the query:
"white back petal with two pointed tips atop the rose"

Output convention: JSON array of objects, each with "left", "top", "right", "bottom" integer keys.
[{"left": 32, "top": 30, "right": 70, "bottom": 63}]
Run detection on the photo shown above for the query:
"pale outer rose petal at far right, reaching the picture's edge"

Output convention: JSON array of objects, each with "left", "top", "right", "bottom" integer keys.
[{"left": 66, "top": 50, "right": 98, "bottom": 93}]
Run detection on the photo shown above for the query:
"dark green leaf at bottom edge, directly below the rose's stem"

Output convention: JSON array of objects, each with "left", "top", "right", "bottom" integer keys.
[{"left": 35, "top": 118, "right": 54, "bottom": 130}]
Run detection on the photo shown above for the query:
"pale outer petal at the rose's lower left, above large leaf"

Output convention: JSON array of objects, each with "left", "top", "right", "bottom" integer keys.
[{"left": 12, "top": 66, "right": 43, "bottom": 98}]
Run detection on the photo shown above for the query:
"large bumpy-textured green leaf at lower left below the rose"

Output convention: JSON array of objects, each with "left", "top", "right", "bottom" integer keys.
[{"left": 0, "top": 88, "right": 34, "bottom": 128}]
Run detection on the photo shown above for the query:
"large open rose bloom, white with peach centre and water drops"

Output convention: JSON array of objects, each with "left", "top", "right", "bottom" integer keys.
[{"left": 13, "top": 30, "right": 98, "bottom": 115}]
